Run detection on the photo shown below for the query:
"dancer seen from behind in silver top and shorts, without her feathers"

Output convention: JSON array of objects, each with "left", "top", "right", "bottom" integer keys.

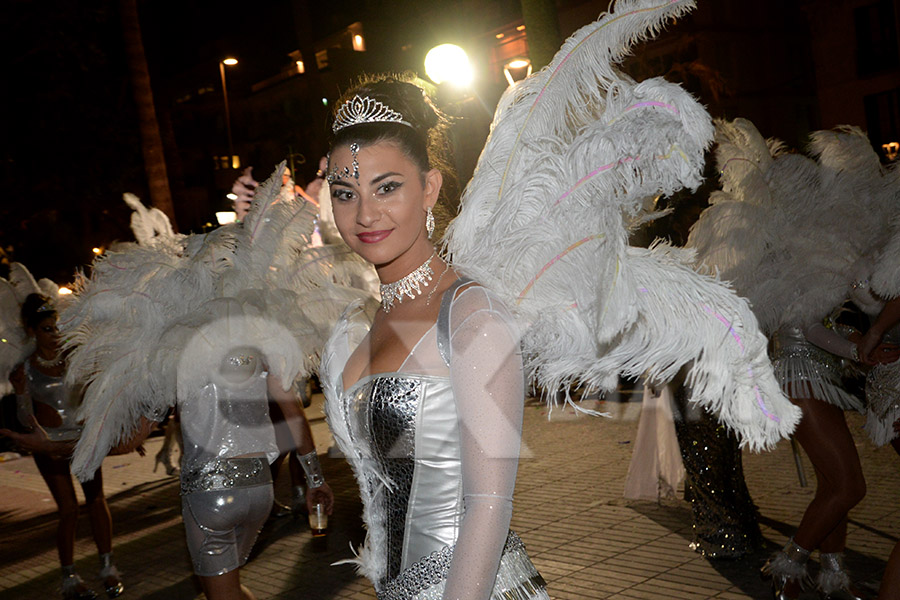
[{"left": 114, "top": 347, "right": 334, "bottom": 600}]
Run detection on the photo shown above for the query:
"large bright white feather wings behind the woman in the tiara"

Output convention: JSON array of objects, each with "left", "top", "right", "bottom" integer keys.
[{"left": 447, "top": 0, "right": 799, "bottom": 449}]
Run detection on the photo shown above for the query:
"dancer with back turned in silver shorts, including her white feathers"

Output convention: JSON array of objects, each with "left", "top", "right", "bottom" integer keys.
[{"left": 62, "top": 170, "right": 362, "bottom": 600}]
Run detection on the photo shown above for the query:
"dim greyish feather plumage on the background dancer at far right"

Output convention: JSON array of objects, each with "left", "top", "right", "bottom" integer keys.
[{"left": 688, "top": 119, "right": 900, "bottom": 334}]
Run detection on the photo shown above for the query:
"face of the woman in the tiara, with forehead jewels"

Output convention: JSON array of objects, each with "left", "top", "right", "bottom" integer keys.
[{"left": 328, "top": 142, "right": 441, "bottom": 280}]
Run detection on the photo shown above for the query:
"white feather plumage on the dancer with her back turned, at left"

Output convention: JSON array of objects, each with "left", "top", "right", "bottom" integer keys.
[{"left": 67, "top": 164, "right": 374, "bottom": 479}]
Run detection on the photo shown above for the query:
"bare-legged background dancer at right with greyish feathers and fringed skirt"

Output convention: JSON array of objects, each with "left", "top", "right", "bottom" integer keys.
[{"left": 689, "top": 119, "right": 900, "bottom": 598}]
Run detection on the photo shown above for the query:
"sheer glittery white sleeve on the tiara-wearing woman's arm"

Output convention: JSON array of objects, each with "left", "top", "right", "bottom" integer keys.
[{"left": 444, "top": 286, "right": 525, "bottom": 600}]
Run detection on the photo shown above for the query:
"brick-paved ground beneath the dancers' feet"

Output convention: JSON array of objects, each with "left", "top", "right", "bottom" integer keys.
[{"left": 0, "top": 396, "right": 900, "bottom": 600}]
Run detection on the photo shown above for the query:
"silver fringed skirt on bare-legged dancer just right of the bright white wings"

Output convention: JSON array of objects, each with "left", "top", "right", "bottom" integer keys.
[{"left": 771, "top": 326, "right": 863, "bottom": 411}]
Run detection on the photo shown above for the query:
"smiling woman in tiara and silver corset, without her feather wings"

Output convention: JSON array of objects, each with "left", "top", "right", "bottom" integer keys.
[{"left": 321, "top": 77, "right": 547, "bottom": 599}]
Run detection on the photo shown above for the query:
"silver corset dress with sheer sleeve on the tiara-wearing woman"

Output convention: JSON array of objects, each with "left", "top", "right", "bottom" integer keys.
[{"left": 322, "top": 286, "right": 548, "bottom": 600}]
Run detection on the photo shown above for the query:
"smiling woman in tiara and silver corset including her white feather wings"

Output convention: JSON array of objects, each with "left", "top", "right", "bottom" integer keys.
[{"left": 321, "top": 0, "right": 799, "bottom": 600}]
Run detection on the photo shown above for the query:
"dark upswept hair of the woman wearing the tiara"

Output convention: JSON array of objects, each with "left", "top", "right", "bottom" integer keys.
[{"left": 331, "top": 73, "right": 457, "bottom": 231}]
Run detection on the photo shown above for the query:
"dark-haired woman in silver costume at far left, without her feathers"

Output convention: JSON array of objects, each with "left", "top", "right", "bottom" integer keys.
[{"left": 4, "top": 294, "right": 125, "bottom": 600}]
